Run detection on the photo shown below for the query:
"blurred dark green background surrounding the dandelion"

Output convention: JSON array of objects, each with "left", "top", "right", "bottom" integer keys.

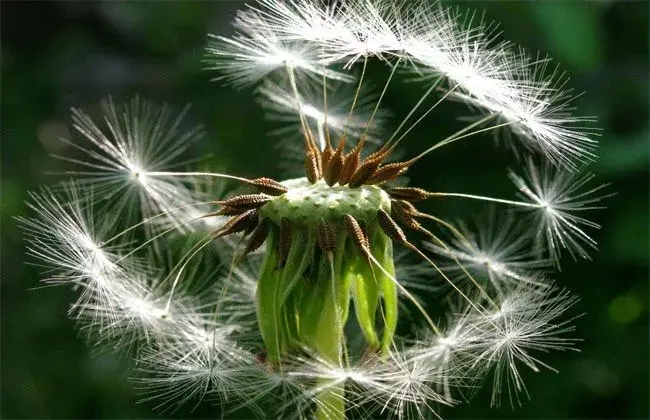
[{"left": 0, "top": 1, "right": 649, "bottom": 419}]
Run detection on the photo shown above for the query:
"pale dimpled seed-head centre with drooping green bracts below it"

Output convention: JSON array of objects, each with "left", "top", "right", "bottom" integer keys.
[{"left": 257, "top": 178, "right": 397, "bottom": 362}]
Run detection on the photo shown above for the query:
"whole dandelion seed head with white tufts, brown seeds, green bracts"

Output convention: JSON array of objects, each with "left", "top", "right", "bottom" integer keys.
[{"left": 19, "top": 0, "right": 604, "bottom": 419}]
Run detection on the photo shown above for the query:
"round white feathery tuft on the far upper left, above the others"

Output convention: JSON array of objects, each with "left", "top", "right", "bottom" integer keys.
[{"left": 54, "top": 98, "right": 210, "bottom": 231}]
